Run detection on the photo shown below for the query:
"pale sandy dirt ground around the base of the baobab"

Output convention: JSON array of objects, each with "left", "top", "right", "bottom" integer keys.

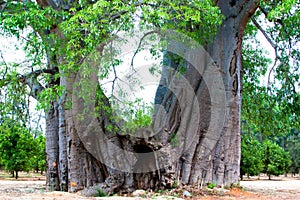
[{"left": 0, "top": 173, "right": 300, "bottom": 200}]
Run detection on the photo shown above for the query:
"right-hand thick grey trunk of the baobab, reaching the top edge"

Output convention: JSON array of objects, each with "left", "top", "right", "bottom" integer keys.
[{"left": 143, "top": 1, "right": 258, "bottom": 188}]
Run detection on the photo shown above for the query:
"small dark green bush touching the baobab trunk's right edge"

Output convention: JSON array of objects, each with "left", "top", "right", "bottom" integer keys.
[{"left": 240, "top": 134, "right": 264, "bottom": 176}]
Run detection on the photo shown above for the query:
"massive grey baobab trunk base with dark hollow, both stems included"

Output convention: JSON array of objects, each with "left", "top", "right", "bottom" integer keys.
[{"left": 44, "top": 0, "right": 258, "bottom": 192}]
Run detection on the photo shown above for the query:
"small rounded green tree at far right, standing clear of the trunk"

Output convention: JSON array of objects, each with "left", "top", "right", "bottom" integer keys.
[{"left": 262, "top": 140, "right": 291, "bottom": 178}]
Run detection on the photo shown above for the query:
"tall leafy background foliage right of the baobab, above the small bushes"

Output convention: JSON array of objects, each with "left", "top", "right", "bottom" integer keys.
[{"left": 241, "top": 0, "right": 300, "bottom": 175}]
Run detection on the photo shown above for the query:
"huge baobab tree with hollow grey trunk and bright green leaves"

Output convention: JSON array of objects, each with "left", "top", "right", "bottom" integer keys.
[{"left": 1, "top": 0, "right": 299, "bottom": 192}]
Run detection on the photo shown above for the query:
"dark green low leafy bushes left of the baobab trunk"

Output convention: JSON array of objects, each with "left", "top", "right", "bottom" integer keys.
[{"left": 0, "top": 122, "right": 46, "bottom": 178}]
